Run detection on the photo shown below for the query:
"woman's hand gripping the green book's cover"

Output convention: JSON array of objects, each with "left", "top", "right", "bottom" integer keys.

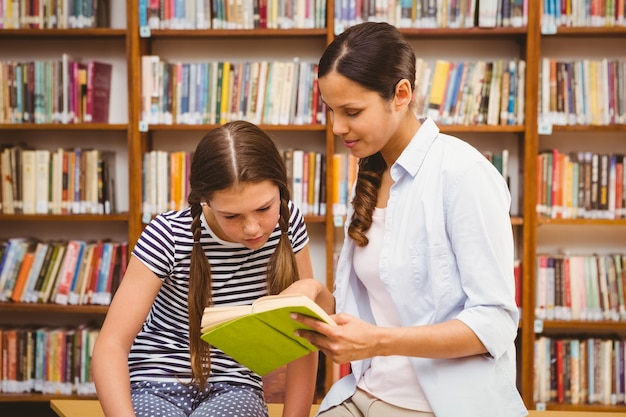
[{"left": 292, "top": 313, "right": 385, "bottom": 363}]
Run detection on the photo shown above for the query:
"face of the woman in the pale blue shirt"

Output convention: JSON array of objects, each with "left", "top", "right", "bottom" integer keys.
[{"left": 319, "top": 71, "right": 401, "bottom": 158}]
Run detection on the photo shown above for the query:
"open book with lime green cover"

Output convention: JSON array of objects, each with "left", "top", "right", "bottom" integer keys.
[{"left": 201, "top": 294, "right": 335, "bottom": 376}]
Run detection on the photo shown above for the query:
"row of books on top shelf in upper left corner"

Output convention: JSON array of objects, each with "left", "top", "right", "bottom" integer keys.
[{"left": 0, "top": 0, "right": 109, "bottom": 29}]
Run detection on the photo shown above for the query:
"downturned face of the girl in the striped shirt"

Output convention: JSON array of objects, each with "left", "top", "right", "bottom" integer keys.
[{"left": 204, "top": 180, "right": 280, "bottom": 249}]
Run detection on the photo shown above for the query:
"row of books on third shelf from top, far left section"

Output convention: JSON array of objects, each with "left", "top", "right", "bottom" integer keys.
[{"left": 0, "top": 145, "right": 116, "bottom": 214}]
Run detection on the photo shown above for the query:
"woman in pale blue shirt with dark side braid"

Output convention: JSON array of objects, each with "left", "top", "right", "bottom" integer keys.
[{"left": 298, "top": 23, "right": 527, "bottom": 417}]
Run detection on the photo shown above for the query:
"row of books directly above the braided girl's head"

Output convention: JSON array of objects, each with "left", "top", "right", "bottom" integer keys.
[{"left": 141, "top": 55, "right": 326, "bottom": 125}]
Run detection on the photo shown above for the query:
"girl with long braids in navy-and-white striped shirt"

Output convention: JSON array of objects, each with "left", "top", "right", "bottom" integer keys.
[{"left": 92, "top": 121, "right": 334, "bottom": 417}]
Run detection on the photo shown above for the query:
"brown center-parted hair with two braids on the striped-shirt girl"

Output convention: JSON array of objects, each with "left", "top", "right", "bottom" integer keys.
[{"left": 187, "top": 121, "right": 298, "bottom": 387}]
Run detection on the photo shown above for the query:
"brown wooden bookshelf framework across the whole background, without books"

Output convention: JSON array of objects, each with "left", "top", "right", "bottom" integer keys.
[{"left": 0, "top": 0, "right": 626, "bottom": 412}]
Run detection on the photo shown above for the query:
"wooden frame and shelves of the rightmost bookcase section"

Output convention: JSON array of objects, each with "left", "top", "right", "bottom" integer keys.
[{"left": 518, "top": 2, "right": 626, "bottom": 415}]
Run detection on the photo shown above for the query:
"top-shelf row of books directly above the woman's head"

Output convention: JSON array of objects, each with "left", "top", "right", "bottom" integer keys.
[{"left": 335, "top": 0, "right": 528, "bottom": 34}]
